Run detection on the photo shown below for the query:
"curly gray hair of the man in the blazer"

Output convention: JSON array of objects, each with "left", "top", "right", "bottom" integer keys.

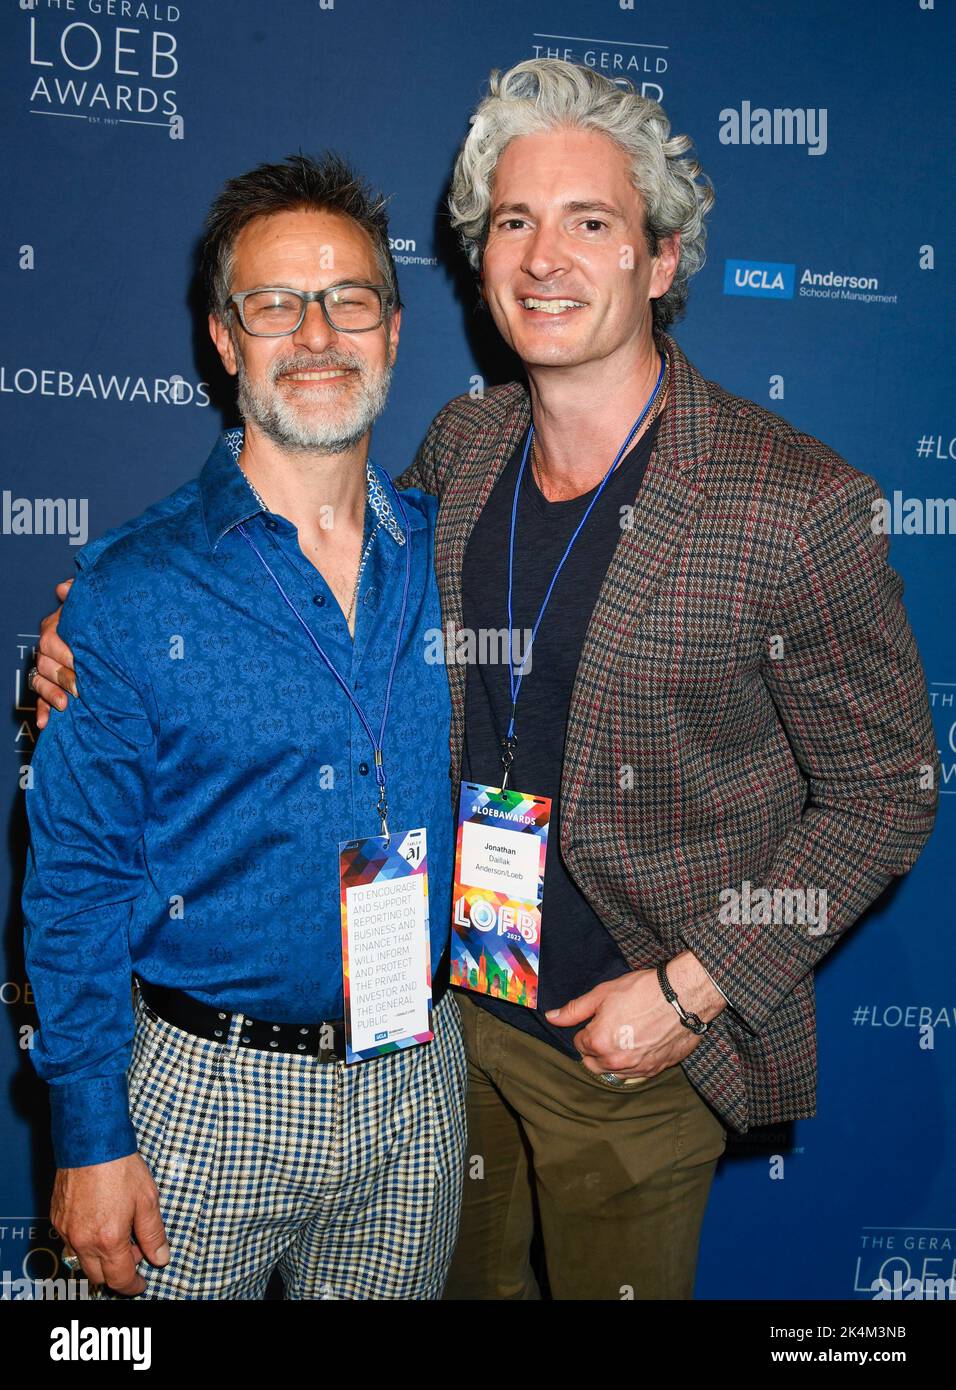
[{"left": 449, "top": 58, "right": 714, "bottom": 328}]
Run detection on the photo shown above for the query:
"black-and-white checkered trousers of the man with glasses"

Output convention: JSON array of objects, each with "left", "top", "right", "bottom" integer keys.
[{"left": 110, "top": 992, "right": 465, "bottom": 1300}]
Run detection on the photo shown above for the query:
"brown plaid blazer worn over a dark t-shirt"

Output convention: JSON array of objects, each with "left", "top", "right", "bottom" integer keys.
[{"left": 399, "top": 334, "right": 939, "bottom": 1131}]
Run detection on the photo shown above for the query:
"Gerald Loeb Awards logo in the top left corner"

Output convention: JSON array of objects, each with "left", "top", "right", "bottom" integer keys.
[{"left": 19, "top": 0, "right": 185, "bottom": 140}]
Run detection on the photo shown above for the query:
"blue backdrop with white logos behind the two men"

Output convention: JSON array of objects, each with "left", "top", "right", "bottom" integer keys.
[{"left": 0, "top": 0, "right": 956, "bottom": 1300}]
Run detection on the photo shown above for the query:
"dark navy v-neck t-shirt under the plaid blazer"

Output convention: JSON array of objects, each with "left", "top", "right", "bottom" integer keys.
[{"left": 461, "top": 420, "right": 660, "bottom": 1058}]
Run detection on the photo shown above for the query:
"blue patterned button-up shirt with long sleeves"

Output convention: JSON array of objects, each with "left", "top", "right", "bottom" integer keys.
[{"left": 24, "top": 431, "right": 453, "bottom": 1168}]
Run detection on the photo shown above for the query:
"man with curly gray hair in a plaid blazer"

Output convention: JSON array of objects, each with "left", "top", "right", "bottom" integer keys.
[{"left": 399, "top": 51, "right": 938, "bottom": 1300}]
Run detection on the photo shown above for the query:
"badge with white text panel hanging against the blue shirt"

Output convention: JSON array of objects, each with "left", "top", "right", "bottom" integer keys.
[{"left": 339, "top": 828, "right": 434, "bottom": 1062}]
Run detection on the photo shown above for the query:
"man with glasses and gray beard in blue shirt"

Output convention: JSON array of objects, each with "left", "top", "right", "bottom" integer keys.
[{"left": 24, "top": 157, "right": 464, "bottom": 1300}]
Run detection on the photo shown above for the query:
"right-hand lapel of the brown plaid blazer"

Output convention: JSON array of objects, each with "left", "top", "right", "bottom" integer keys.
[{"left": 561, "top": 334, "right": 710, "bottom": 858}]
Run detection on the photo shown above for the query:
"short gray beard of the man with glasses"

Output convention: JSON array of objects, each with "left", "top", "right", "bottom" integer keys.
[{"left": 236, "top": 352, "right": 392, "bottom": 453}]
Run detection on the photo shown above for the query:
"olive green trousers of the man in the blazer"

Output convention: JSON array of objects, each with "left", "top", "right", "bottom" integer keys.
[{"left": 445, "top": 990, "right": 727, "bottom": 1300}]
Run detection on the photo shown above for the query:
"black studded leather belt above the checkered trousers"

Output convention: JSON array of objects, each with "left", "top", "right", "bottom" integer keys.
[{"left": 136, "top": 955, "right": 449, "bottom": 1062}]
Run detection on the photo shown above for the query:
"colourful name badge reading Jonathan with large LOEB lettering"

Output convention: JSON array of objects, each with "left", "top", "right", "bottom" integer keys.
[{"left": 450, "top": 783, "right": 552, "bottom": 1009}]
